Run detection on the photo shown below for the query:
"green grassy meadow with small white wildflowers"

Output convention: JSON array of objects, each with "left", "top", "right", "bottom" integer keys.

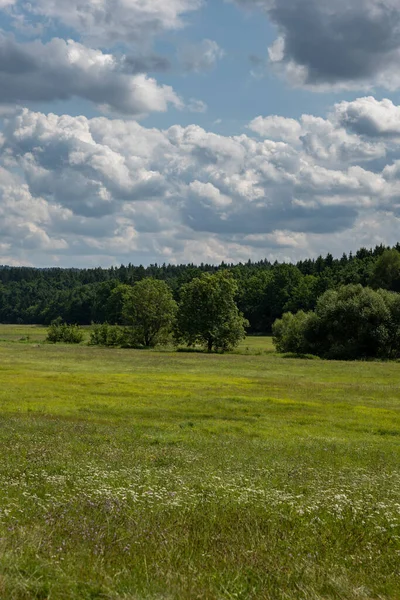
[{"left": 0, "top": 326, "right": 400, "bottom": 600}]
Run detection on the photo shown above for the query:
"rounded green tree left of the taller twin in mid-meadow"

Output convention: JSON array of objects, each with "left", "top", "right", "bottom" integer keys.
[{"left": 122, "top": 278, "right": 177, "bottom": 348}]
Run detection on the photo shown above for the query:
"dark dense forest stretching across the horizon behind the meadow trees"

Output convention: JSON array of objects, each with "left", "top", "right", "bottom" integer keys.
[{"left": 0, "top": 244, "right": 400, "bottom": 333}]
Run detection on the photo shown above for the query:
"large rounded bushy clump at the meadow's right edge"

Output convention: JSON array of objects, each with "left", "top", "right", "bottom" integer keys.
[{"left": 273, "top": 285, "right": 400, "bottom": 360}]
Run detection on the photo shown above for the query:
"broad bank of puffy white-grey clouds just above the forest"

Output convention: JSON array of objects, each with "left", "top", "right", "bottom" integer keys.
[{"left": 0, "top": 98, "right": 400, "bottom": 264}]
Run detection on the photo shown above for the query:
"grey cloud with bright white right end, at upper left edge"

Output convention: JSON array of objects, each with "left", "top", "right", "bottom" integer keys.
[{"left": 0, "top": 35, "right": 183, "bottom": 116}]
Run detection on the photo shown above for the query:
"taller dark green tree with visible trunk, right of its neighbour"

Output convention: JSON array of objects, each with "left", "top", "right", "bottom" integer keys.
[{"left": 177, "top": 271, "right": 248, "bottom": 352}]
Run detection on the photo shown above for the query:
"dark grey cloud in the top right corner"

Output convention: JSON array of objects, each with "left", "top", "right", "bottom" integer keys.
[{"left": 235, "top": 0, "right": 400, "bottom": 90}]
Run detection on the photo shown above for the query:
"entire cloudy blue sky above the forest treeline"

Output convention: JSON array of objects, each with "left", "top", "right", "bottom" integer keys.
[{"left": 0, "top": 0, "right": 400, "bottom": 267}]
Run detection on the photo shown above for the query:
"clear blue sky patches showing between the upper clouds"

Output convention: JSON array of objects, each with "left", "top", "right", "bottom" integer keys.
[{"left": 0, "top": 0, "right": 372, "bottom": 130}]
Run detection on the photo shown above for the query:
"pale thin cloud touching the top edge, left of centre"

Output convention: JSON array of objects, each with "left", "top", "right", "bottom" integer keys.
[{"left": 10, "top": 0, "right": 202, "bottom": 47}]
